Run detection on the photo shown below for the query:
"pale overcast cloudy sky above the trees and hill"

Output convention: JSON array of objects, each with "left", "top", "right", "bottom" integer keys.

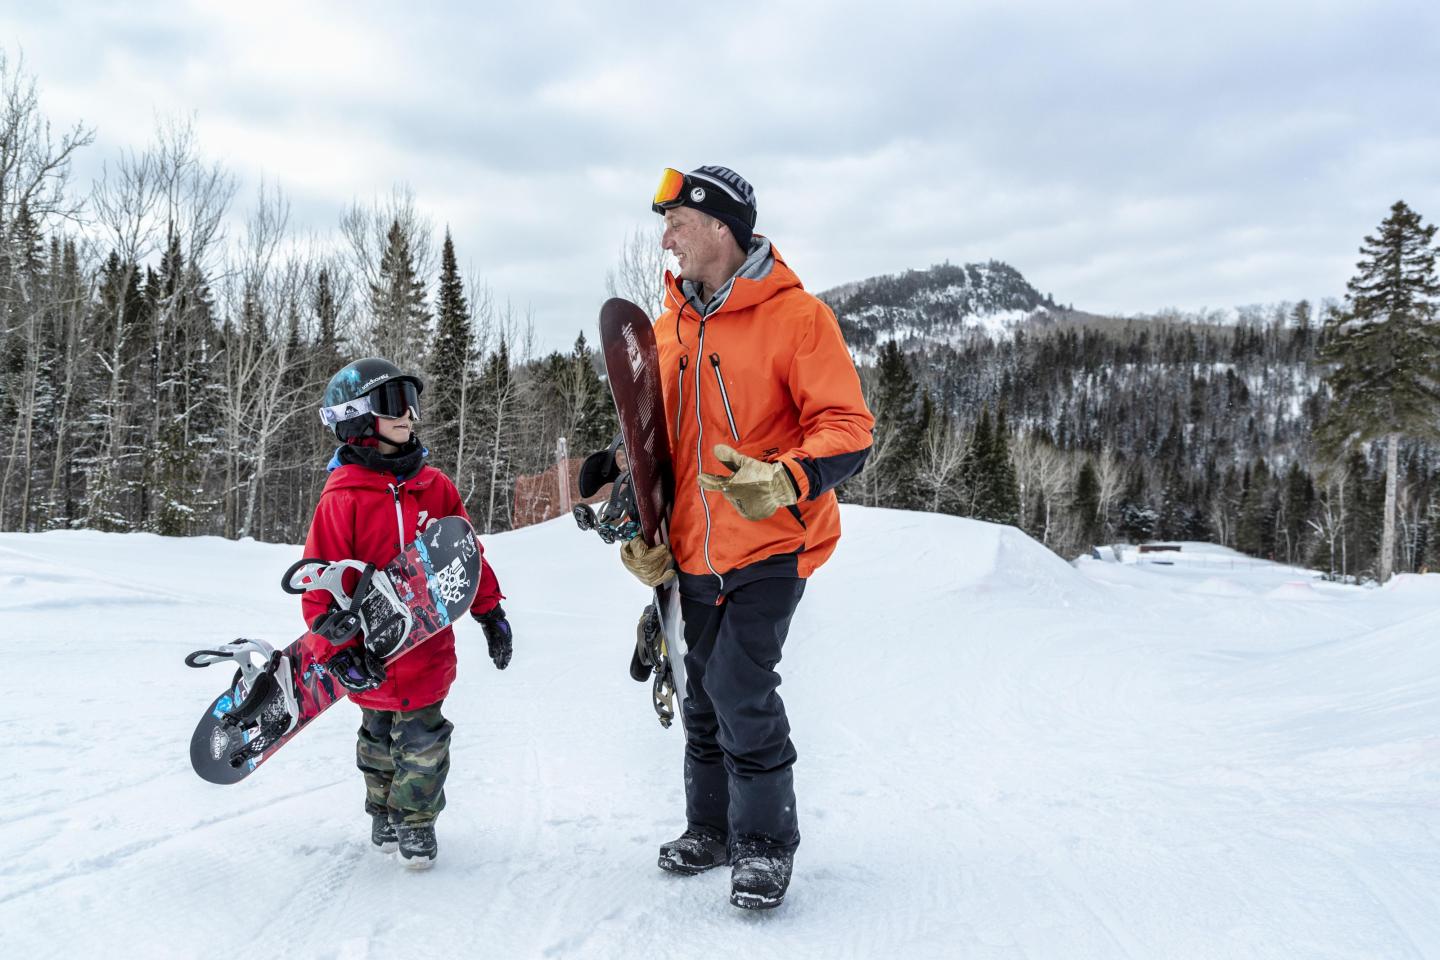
[{"left": 0, "top": 0, "right": 1440, "bottom": 347}]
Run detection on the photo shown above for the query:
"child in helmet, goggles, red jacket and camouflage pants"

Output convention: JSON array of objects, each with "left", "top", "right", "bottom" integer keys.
[{"left": 302, "top": 357, "right": 511, "bottom": 869}]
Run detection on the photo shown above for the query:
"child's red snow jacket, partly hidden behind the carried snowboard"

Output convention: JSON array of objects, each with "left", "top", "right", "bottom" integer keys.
[{"left": 301, "top": 463, "right": 503, "bottom": 710}]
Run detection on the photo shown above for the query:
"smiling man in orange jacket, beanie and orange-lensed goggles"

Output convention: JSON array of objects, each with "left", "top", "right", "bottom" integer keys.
[{"left": 622, "top": 167, "right": 874, "bottom": 908}]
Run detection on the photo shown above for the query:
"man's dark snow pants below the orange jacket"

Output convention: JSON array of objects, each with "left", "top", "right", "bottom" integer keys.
[{"left": 680, "top": 574, "right": 805, "bottom": 851}]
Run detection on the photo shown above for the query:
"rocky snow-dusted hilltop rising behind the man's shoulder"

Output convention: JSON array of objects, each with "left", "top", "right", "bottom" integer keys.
[{"left": 819, "top": 261, "right": 1058, "bottom": 354}]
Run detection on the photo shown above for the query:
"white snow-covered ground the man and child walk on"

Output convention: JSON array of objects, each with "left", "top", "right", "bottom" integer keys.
[{"left": 0, "top": 508, "right": 1440, "bottom": 960}]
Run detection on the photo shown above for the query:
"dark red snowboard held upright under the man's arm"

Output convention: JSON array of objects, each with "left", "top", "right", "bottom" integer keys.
[{"left": 575, "top": 296, "right": 685, "bottom": 727}]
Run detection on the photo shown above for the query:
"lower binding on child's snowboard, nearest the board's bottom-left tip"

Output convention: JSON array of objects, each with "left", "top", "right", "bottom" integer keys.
[{"left": 184, "top": 639, "right": 300, "bottom": 767}]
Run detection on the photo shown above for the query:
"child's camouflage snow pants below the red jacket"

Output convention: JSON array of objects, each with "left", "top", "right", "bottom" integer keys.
[{"left": 356, "top": 701, "right": 455, "bottom": 823}]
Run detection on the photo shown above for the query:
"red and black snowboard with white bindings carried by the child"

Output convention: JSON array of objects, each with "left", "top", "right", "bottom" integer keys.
[{"left": 186, "top": 517, "right": 481, "bottom": 783}]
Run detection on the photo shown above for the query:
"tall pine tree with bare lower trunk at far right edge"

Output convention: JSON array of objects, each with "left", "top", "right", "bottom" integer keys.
[{"left": 1319, "top": 201, "right": 1440, "bottom": 581}]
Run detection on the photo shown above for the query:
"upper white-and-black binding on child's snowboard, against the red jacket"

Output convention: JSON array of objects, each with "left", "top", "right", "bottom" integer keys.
[{"left": 279, "top": 557, "right": 410, "bottom": 659}]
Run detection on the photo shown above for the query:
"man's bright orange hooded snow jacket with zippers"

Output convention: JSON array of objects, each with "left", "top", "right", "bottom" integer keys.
[{"left": 655, "top": 236, "right": 876, "bottom": 592}]
